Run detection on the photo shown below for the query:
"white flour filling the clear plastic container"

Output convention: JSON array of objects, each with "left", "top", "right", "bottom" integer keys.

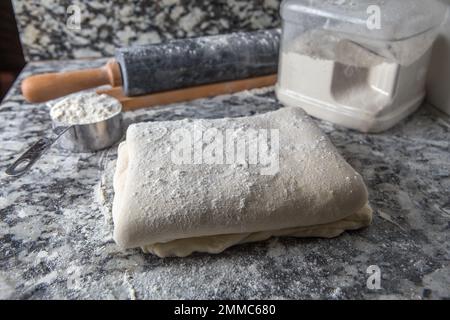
[{"left": 277, "top": 30, "right": 433, "bottom": 131}]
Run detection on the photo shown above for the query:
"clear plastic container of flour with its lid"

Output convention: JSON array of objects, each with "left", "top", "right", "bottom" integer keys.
[{"left": 277, "top": 0, "right": 446, "bottom": 132}]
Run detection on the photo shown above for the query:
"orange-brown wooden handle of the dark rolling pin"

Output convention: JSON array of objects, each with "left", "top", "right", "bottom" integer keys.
[{"left": 22, "top": 60, "right": 122, "bottom": 102}]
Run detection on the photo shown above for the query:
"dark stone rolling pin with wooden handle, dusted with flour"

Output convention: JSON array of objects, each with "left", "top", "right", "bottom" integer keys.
[{"left": 22, "top": 29, "right": 281, "bottom": 102}]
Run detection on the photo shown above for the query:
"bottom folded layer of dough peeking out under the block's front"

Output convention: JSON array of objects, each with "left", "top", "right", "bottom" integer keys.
[{"left": 141, "top": 204, "right": 372, "bottom": 258}]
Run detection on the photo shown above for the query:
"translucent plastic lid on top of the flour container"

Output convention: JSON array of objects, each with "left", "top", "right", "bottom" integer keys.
[{"left": 281, "top": 0, "right": 447, "bottom": 41}]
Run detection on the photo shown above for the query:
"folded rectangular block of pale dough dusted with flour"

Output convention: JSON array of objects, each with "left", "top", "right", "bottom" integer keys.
[{"left": 113, "top": 108, "right": 372, "bottom": 257}]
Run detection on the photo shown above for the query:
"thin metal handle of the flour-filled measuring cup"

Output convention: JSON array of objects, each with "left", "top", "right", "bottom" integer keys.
[{"left": 5, "top": 138, "right": 55, "bottom": 176}]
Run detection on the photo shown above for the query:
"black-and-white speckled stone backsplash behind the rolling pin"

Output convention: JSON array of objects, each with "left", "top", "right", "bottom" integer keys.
[{"left": 13, "top": 0, "right": 281, "bottom": 61}]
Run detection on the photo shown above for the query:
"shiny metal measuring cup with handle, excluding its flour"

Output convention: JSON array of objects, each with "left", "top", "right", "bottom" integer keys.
[{"left": 5, "top": 104, "right": 123, "bottom": 176}]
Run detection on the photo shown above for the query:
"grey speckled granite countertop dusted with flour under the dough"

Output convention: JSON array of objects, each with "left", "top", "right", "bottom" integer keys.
[{"left": 0, "top": 60, "right": 450, "bottom": 299}]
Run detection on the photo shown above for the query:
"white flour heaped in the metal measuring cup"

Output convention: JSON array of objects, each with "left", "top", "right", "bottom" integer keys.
[{"left": 50, "top": 92, "right": 122, "bottom": 125}]
